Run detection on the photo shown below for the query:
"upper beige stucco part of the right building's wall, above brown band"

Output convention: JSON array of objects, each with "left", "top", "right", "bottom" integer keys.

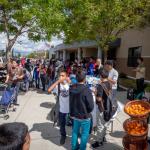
[{"left": 117, "top": 27, "right": 150, "bottom": 58}]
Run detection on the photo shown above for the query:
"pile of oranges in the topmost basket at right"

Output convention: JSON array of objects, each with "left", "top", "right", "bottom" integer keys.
[{"left": 126, "top": 104, "right": 148, "bottom": 115}]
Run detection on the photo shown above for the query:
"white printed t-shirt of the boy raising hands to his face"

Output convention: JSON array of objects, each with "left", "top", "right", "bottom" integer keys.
[{"left": 55, "top": 83, "right": 69, "bottom": 113}]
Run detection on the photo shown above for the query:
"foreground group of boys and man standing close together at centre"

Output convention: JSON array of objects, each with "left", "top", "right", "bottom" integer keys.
[{"left": 48, "top": 59, "right": 118, "bottom": 150}]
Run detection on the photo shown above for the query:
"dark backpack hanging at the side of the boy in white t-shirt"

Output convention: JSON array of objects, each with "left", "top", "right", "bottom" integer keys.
[{"left": 49, "top": 84, "right": 60, "bottom": 126}]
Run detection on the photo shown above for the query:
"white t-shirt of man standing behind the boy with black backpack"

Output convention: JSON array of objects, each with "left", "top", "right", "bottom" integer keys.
[{"left": 108, "top": 68, "right": 118, "bottom": 90}]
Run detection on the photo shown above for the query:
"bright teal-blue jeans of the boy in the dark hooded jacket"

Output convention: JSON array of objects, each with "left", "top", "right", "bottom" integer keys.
[{"left": 72, "top": 119, "right": 91, "bottom": 150}]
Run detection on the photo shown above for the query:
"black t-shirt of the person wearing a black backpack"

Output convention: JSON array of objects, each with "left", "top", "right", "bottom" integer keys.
[{"left": 97, "top": 81, "right": 111, "bottom": 108}]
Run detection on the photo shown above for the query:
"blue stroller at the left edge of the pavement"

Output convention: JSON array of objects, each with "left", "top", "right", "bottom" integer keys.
[{"left": 0, "top": 84, "right": 17, "bottom": 120}]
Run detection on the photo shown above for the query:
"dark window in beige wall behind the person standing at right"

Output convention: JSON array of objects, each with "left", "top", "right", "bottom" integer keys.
[{"left": 128, "top": 46, "right": 142, "bottom": 67}]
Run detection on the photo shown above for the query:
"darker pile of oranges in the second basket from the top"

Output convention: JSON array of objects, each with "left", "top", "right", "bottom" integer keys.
[{"left": 126, "top": 122, "right": 146, "bottom": 135}]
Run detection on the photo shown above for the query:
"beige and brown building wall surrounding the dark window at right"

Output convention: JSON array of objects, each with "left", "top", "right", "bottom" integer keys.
[{"left": 116, "top": 27, "right": 150, "bottom": 80}]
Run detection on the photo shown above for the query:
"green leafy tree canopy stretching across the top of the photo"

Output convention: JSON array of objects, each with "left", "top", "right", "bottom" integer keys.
[{"left": 0, "top": 0, "right": 150, "bottom": 59}]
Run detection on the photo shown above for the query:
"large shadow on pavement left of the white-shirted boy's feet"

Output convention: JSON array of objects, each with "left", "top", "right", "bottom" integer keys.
[{"left": 29, "top": 122, "right": 71, "bottom": 150}]
